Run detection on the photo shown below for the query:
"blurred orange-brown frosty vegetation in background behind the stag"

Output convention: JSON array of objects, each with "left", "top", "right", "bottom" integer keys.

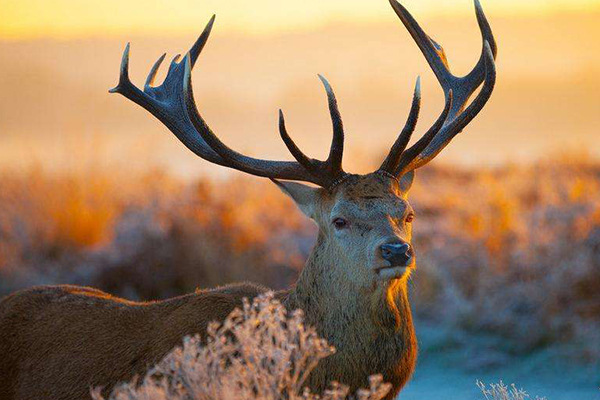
[{"left": 0, "top": 157, "right": 600, "bottom": 361}]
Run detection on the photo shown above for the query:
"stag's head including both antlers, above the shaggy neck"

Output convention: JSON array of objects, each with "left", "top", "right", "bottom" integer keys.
[{"left": 111, "top": 0, "right": 496, "bottom": 294}]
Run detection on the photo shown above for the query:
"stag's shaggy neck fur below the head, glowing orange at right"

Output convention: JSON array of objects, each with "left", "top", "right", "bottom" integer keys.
[{"left": 283, "top": 234, "right": 417, "bottom": 399}]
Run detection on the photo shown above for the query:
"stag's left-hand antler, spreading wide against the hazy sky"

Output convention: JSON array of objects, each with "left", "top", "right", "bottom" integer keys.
[{"left": 110, "top": 16, "right": 346, "bottom": 187}]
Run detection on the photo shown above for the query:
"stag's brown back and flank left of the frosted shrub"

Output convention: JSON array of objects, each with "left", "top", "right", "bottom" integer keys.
[{"left": 0, "top": 285, "right": 265, "bottom": 400}]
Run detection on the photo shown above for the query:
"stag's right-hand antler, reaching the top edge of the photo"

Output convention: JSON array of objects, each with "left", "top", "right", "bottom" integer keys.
[{"left": 380, "top": 0, "right": 497, "bottom": 176}]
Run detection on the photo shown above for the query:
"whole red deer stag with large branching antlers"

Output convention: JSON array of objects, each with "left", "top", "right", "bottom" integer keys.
[{"left": 0, "top": 0, "right": 496, "bottom": 400}]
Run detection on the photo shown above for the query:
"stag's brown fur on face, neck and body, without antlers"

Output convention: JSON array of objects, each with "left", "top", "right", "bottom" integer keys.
[{"left": 0, "top": 174, "right": 417, "bottom": 400}]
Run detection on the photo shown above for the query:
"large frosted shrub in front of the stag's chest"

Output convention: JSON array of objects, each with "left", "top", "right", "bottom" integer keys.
[{"left": 92, "top": 294, "right": 391, "bottom": 400}]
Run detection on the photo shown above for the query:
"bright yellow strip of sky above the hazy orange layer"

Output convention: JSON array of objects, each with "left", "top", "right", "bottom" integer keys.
[{"left": 0, "top": 0, "right": 600, "bottom": 39}]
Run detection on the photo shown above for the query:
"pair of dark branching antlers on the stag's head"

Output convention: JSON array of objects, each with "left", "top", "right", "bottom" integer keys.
[{"left": 110, "top": 0, "right": 496, "bottom": 188}]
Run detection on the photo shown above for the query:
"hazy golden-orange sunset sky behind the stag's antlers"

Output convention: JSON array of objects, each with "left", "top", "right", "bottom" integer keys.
[{"left": 0, "top": 0, "right": 600, "bottom": 172}]
